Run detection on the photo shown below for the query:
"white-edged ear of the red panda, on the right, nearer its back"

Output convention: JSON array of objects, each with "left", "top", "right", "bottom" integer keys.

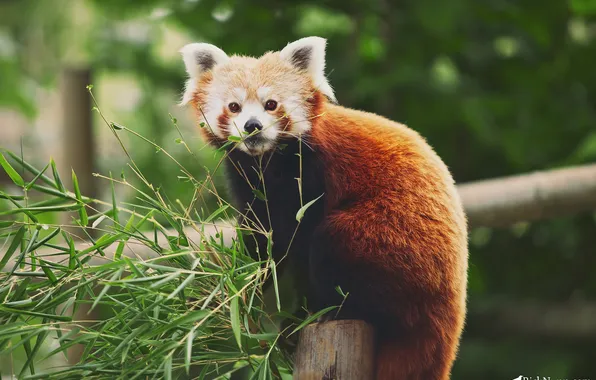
[{"left": 280, "top": 37, "right": 336, "bottom": 102}]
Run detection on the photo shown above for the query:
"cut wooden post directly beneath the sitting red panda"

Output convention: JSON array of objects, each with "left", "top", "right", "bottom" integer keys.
[{"left": 294, "top": 320, "right": 375, "bottom": 380}]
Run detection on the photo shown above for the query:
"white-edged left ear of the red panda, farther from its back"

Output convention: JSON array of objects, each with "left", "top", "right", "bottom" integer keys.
[{"left": 180, "top": 43, "right": 229, "bottom": 105}]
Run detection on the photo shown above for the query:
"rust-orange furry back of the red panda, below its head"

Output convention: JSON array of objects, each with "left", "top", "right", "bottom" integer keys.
[{"left": 311, "top": 104, "right": 467, "bottom": 379}]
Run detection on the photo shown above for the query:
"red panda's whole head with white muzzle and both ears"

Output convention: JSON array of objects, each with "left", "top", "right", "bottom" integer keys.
[{"left": 182, "top": 37, "right": 334, "bottom": 155}]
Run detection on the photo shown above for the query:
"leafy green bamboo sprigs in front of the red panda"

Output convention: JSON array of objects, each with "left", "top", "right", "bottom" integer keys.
[{"left": 0, "top": 98, "right": 335, "bottom": 379}]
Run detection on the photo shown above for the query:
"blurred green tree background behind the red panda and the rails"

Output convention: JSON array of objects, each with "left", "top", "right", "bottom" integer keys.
[{"left": 0, "top": 0, "right": 596, "bottom": 379}]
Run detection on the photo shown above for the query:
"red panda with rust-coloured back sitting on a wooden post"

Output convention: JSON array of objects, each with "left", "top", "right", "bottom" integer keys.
[{"left": 181, "top": 37, "right": 468, "bottom": 380}]
